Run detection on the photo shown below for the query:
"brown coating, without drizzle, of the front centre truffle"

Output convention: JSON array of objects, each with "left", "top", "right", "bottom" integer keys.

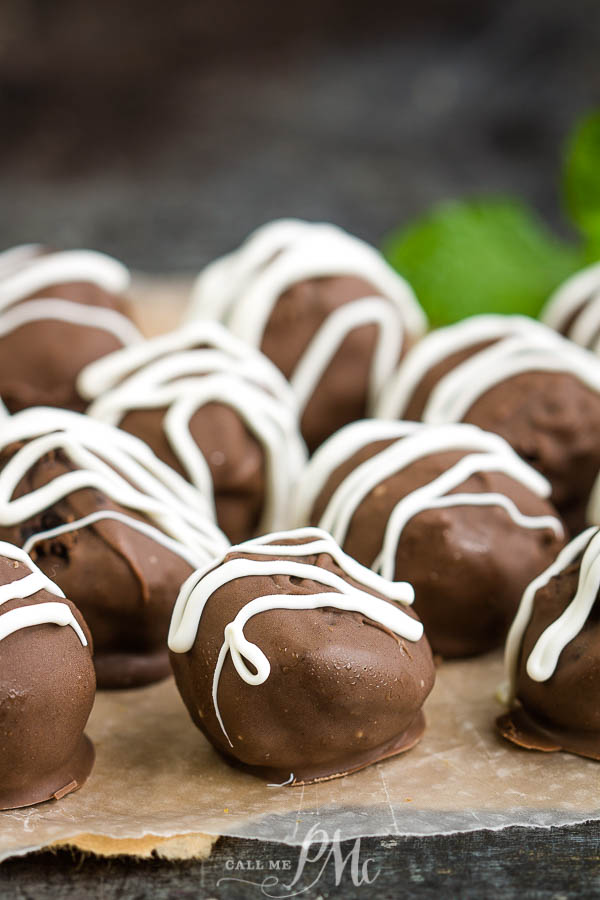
[{"left": 171, "top": 541, "right": 435, "bottom": 784}]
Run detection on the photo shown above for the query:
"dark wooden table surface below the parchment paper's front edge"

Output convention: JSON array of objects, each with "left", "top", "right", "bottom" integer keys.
[{"left": 0, "top": 822, "right": 600, "bottom": 900}]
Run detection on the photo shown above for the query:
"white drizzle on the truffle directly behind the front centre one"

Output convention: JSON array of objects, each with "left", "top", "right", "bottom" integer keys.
[{"left": 79, "top": 322, "right": 306, "bottom": 532}]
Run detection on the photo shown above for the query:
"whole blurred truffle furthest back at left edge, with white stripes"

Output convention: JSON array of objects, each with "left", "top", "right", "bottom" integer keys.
[{"left": 0, "top": 245, "right": 141, "bottom": 412}]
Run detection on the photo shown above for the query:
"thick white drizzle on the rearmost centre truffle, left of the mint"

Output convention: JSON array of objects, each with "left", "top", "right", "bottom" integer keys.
[{"left": 188, "top": 219, "right": 427, "bottom": 409}]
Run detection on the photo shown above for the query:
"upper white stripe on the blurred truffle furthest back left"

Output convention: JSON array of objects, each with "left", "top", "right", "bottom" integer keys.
[{"left": 0, "top": 250, "right": 130, "bottom": 309}]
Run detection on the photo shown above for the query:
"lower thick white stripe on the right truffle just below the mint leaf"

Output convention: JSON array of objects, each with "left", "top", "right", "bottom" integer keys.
[{"left": 423, "top": 335, "right": 600, "bottom": 424}]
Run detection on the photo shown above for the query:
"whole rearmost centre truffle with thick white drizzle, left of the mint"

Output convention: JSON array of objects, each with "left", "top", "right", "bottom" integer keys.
[{"left": 189, "top": 220, "right": 426, "bottom": 451}]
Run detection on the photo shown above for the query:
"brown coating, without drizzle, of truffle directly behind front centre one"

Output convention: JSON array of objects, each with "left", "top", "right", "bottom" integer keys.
[{"left": 119, "top": 403, "right": 266, "bottom": 543}]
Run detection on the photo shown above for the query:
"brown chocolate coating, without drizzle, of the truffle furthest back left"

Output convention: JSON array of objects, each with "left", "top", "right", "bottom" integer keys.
[{"left": 0, "top": 282, "right": 135, "bottom": 412}]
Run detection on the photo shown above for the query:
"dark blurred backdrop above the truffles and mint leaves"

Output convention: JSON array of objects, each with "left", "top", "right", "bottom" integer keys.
[{"left": 0, "top": 0, "right": 600, "bottom": 271}]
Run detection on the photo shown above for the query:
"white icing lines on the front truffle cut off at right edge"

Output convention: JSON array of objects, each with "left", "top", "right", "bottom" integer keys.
[{"left": 501, "top": 527, "right": 600, "bottom": 705}]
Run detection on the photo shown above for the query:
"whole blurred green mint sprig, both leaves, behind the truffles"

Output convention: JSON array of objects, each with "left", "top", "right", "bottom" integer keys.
[{"left": 383, "top": 110, "right": 600, "bottom": 327}]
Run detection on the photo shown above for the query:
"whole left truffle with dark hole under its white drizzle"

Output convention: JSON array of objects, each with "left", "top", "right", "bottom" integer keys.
[{"left": 0, "top": 408, "right": 228, "bottom": 688}]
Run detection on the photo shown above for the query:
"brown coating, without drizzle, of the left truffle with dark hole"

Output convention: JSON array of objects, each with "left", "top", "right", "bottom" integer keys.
[{"left": 0, "top": 445, "right": 192, "bottom": 688}]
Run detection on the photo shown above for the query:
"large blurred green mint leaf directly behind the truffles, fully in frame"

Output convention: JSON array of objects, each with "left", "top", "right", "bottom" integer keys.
[{"left": 383, "top": 198, "right": 583, "bottom": 327}]
